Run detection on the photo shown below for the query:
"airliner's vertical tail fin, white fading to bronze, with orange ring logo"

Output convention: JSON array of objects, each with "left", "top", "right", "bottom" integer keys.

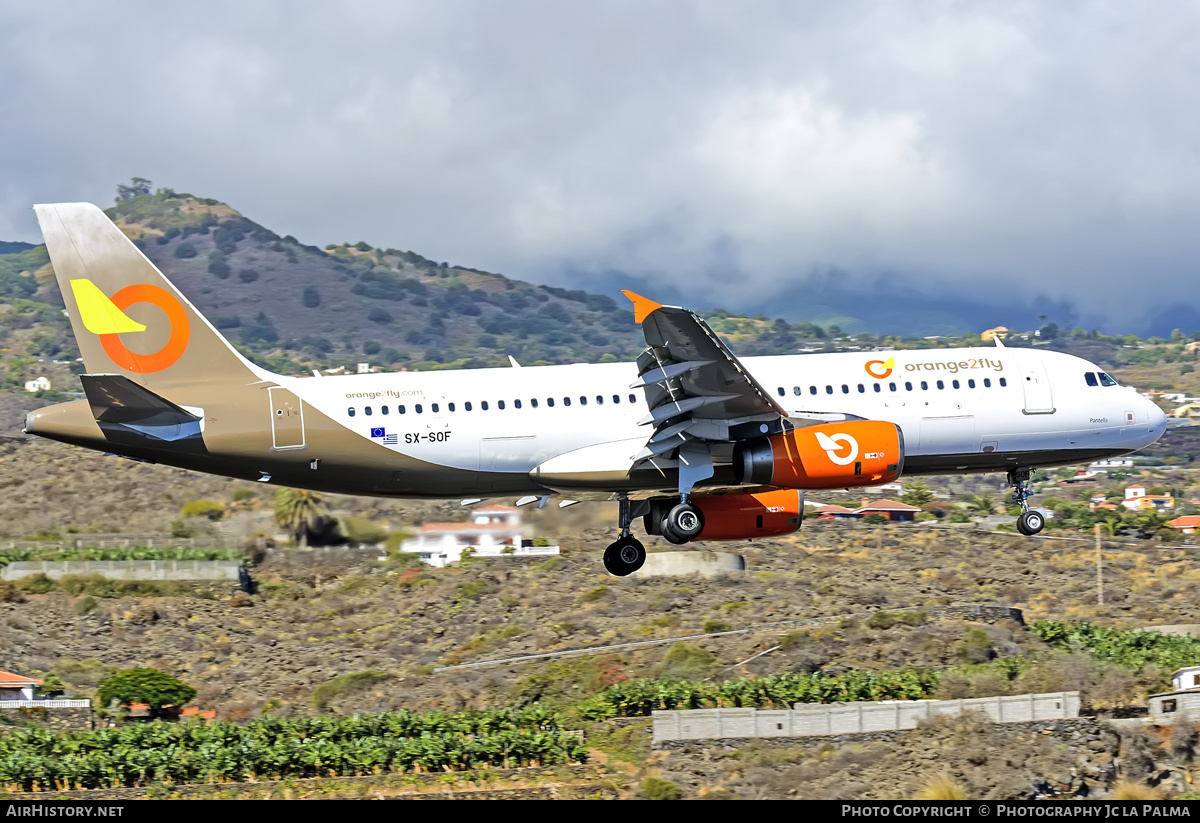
[{"left": 34, "top": 203, "right": 265, "bottom": 390}]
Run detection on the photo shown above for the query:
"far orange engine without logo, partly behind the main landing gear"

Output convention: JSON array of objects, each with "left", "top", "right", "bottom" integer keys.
[{"left": 642, "top": 488, "right": 804, "bottom": 542}]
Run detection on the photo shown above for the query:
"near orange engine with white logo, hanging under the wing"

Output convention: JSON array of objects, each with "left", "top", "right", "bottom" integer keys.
[{"left": 733, "top": 420, "right": 904, "bottom": 488}]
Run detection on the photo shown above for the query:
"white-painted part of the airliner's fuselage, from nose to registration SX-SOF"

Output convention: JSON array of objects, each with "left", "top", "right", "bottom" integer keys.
[{"left": 286, "top": 348, "right": 1165, "bottom": 487}]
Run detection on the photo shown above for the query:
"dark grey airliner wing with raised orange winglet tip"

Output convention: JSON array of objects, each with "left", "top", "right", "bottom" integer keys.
[{"left": 624, "top": 292, "right": 787, "bottom": 479}]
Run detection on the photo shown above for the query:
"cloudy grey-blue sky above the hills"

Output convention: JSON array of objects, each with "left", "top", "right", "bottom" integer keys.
[{"left": 0, "top": 0, "right": 1200, "bottom": 328}]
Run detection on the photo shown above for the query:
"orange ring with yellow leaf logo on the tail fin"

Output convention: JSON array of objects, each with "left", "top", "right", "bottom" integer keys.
[{"left": 71, "top": 280, "right": 191, "bottom": 374}]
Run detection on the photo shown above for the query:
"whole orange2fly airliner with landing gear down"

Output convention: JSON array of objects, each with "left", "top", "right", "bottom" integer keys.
[{"left": 25, "top": 203, "right": 1166, "bottom": 576}]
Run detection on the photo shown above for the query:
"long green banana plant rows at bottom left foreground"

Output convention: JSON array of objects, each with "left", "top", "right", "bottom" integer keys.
[{"left": 0, "top": 707, "right": 587, "bottom": 792}]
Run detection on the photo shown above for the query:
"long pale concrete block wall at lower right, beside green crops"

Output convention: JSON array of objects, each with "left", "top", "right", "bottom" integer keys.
[{"left": 654, "top": 691, "right": 1079, "bottom": 743}]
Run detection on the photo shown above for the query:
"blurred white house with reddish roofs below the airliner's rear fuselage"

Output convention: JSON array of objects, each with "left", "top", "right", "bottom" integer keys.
[{"left": 400, "top": 505, "right": 558, "bottom": 569}]
